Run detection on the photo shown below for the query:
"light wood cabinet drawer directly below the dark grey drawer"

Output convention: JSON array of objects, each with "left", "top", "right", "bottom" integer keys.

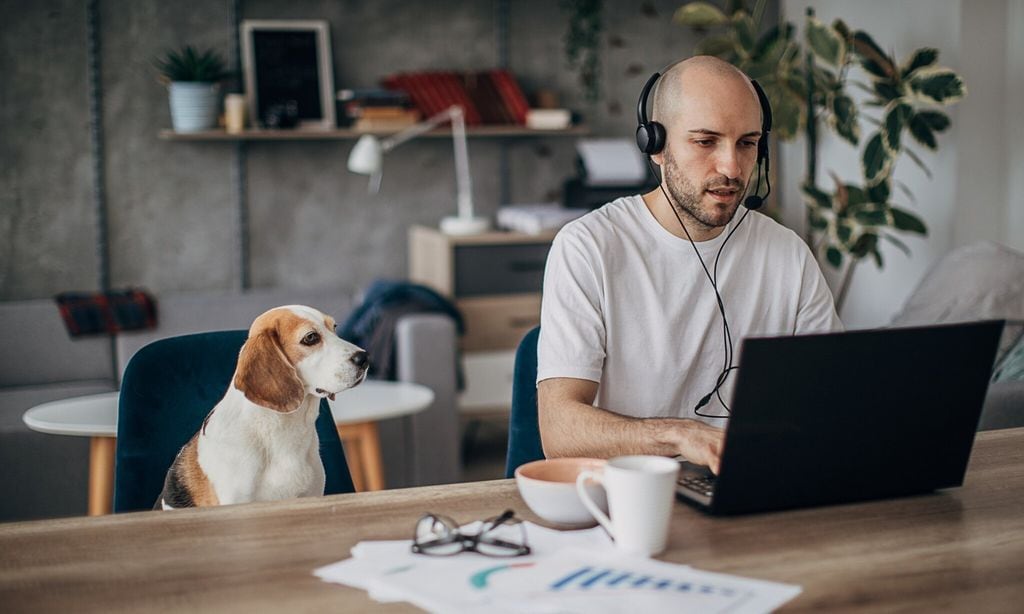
[{"left": 456, "top": 294, "right": 541, "bottom": 352}]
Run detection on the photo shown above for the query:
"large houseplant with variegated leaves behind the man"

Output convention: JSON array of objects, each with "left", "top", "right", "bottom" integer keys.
[{"left": 673, "top": 0, "right": 967, "bottom": 307}]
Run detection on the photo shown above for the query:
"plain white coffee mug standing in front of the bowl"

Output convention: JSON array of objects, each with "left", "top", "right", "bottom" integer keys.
[{"left": 577, "top": 456, "right": 679, "bottom": 557}]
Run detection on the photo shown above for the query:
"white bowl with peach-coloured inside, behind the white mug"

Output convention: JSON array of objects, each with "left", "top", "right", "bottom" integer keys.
[{"left": 515, "top": 458, "right": 608, "bottom": 527}]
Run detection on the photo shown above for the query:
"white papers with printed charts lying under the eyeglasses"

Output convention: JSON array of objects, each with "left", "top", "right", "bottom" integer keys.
[{"left": 314, "top": 523, "right": 800, "bottom": 614}]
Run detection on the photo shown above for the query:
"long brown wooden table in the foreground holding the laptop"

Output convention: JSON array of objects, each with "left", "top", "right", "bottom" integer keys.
[{"left": 0, "top": 429, "right": 1024, "bottom": 612}]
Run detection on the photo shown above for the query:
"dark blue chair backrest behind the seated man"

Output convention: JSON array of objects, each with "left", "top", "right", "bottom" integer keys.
[{"left": 505, "top": 326, "right": 544, "bottom": 478}]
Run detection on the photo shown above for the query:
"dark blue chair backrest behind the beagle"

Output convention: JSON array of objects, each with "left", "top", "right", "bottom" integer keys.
[{"left": 114, "top": 331, "right": 355, "bottom": 512}]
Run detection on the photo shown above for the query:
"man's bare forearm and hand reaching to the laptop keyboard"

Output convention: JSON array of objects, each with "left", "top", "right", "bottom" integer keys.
[{"left": 537, "top": 378, "right": 724, "bottom": 474}]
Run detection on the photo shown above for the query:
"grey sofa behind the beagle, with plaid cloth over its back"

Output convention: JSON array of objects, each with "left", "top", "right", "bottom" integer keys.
[{"left": 0, "top": 289, "right": 459, "bottom": 521}]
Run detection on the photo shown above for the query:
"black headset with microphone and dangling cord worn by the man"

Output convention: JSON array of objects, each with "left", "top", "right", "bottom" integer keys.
[{"left": 637, "top": 67, "right": 771, "bottom": 418}]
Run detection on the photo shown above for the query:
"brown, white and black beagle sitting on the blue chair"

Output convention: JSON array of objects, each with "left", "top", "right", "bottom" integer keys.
[{"left": 154, "top": 305, "right": 369, "bottom": 510}]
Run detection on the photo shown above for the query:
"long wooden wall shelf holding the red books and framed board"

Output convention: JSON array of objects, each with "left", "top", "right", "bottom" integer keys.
[{"left": 160, "top": 126, "right": 590, "bottom": 141}]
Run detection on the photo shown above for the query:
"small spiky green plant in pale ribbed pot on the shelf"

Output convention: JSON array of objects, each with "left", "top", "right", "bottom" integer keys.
[{"left": 156, "top": 45, "right": 230, "bottom": 132}]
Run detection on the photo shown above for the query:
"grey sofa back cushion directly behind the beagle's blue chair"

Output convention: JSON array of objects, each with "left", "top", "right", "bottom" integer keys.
[{"left": 117, "top": 288, "right": 353, "bottom": 382}]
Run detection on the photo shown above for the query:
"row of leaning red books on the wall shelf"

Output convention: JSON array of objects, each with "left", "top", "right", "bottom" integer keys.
[{"left": 382, "top": 69, "right": 529, "bottom": 126}]
